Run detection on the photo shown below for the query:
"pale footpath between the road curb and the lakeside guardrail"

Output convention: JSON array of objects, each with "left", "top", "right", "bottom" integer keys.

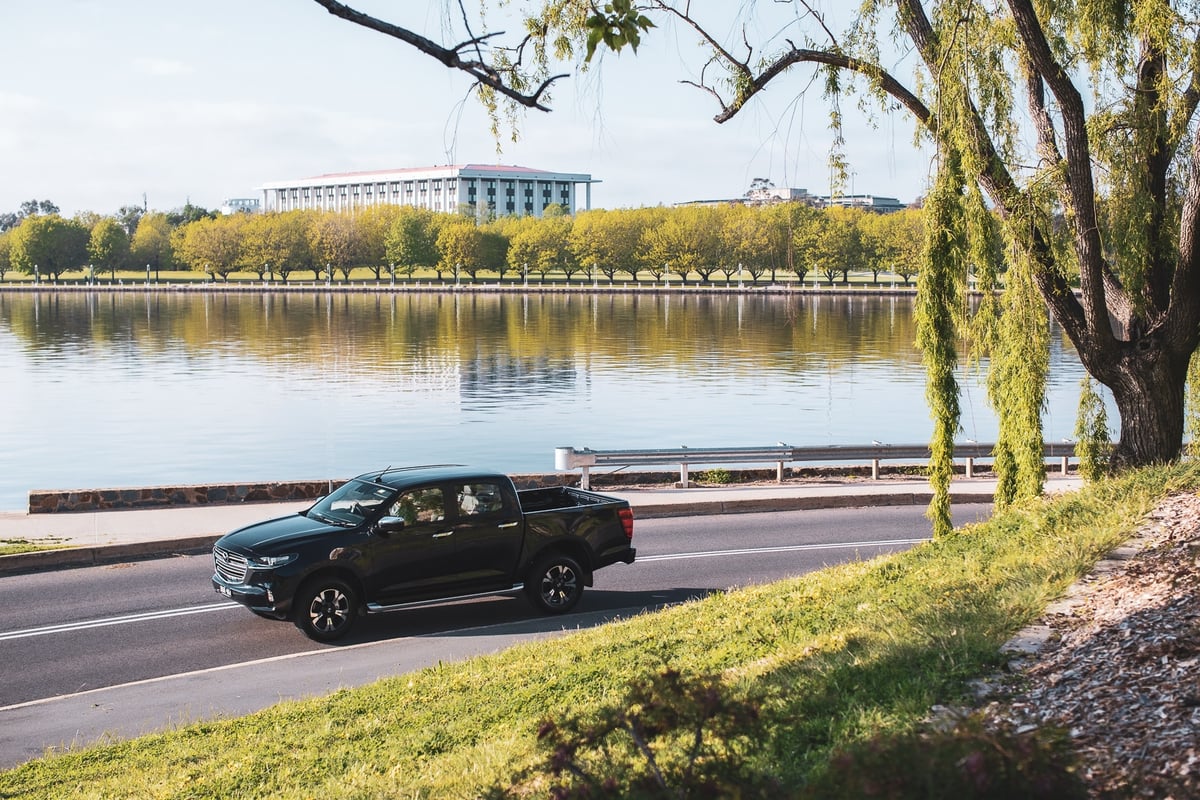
[{"left": 0, "top": 474, "right": 1082, "bottom": 575}]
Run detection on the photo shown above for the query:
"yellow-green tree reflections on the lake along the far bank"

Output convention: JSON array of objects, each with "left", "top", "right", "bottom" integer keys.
[{"left": 0, "top": 291, "right": 1032, "bottom": 381}]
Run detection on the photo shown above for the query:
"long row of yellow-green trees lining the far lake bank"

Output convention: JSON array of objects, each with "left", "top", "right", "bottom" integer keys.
[{"left": 0, "top": 203, "right": 925, "bottom": 284}]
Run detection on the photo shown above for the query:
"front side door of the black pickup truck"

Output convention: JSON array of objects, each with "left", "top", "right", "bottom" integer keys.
[{"left": 367, "top": 486, "right": 457, "bottom": 603}]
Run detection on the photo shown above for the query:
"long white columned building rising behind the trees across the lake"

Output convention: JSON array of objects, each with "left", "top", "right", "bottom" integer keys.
[{"left": 263, "top": 164, "right": 599, "bottom": 217}]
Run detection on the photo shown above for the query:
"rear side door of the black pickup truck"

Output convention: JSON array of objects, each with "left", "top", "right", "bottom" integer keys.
[{"left": 451, "top": 479, "right": 524, "bottom": 591}]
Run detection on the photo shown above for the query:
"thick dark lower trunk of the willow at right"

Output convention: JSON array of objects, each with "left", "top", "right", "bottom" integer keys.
[{"left": 1093, "top": 339, "right": 1188, "bottom": 469}]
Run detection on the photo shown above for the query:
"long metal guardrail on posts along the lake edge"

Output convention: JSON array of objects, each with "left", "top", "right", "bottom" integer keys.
[{"left": 554, "top": 441, "right": 1075, "bottom": 489}]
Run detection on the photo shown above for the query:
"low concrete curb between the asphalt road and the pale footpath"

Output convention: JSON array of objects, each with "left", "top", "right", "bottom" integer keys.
[{"left": 0, "top": 492, "right": 992, "bottom": 576}]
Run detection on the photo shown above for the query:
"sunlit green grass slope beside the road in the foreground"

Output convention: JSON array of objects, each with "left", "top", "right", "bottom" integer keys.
[{"left": 0, "top": 467, "right": 1200, "bottom": 799}]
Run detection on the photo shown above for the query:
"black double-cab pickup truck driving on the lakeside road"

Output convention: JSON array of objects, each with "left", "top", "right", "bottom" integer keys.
[{"left": 212, "top": 465, "right": 637, "bottom": 642}]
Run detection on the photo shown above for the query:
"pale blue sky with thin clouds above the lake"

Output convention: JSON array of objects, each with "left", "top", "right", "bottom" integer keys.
[{"left": 0, "top": 0, "right": 931, "bottom": 216}]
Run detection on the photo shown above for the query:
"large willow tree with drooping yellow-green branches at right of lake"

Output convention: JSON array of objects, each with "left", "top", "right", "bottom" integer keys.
[{"left": 316, "top": 0, "right": 1200, "bottom": 530}]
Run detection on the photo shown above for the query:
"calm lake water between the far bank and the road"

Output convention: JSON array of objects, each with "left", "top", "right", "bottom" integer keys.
[{"left": 0, "top": 291, "right": 1099, "bottom": 510}]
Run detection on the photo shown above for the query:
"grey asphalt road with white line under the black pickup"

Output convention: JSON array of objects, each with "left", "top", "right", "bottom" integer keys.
[{"left": 0, "top": 505, "right": 990, "bottom": 769}]
